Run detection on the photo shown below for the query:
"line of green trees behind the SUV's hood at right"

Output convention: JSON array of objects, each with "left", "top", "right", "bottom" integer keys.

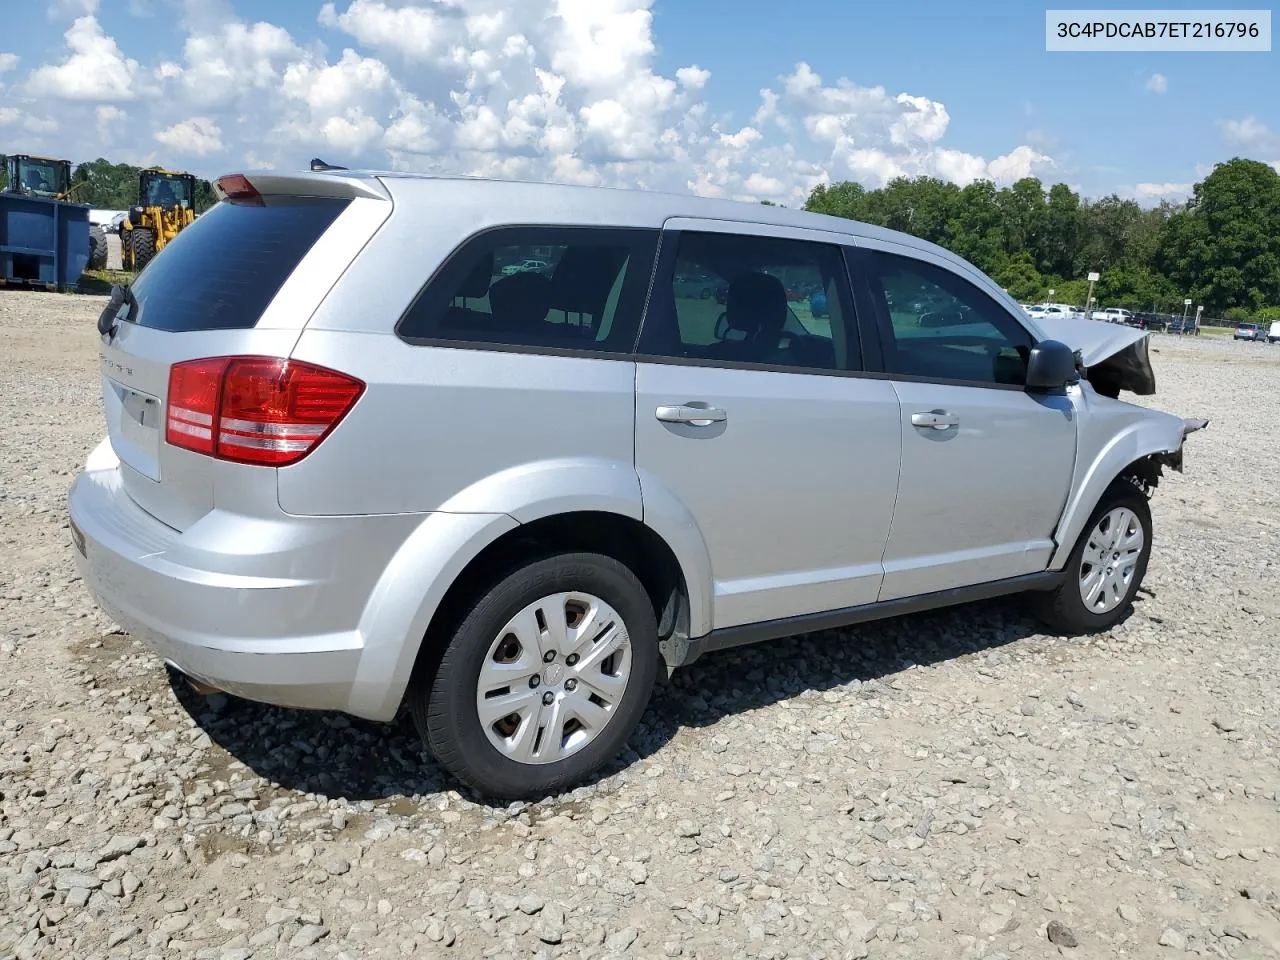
[{"left": 805, "top": 159, "right": 1280, "bottom": 320}]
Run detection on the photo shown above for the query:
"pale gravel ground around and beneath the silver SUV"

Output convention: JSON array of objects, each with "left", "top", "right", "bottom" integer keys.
[{"left": 0, "top": 293, "right": 1280, "bottom": 960}]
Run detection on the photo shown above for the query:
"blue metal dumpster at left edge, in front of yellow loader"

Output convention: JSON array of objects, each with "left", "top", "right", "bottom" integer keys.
[{"left": 0, "top": 193, "right": 90, "bottom": 291}]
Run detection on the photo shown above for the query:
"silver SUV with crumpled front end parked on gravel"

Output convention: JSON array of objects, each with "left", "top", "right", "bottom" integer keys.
[{"left": 69, "top": 172, "right": 1202, "bottom": 797}]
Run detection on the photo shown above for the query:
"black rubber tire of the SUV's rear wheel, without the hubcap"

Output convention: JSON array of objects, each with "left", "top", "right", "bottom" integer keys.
[{"left": 410, "top": 553, "right": 659, "bottom": 800}]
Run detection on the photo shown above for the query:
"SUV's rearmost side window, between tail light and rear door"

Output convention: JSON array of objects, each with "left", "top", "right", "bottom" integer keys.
[{"left": 398, "top": 227, "right": 657, "bottom": 353}]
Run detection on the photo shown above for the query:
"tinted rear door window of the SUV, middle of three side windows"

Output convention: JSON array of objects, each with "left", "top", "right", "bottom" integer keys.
[{"left": 640, "top": 232, "right": 861, "bottom": 370}]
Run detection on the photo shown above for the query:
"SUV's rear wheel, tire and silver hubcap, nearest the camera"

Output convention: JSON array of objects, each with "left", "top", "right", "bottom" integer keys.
[{"left": 411, "top": 553, "right": 659, "bottom": 800}]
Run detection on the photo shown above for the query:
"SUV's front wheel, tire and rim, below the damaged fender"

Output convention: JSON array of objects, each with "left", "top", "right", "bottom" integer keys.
[{"left": 1032, "top": 479, "right": 1151, "bottom": 635}]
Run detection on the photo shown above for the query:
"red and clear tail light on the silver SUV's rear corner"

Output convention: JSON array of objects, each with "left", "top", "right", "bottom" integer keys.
[{"left": 165, "top": 357, "right": 365, "bottom": 467}]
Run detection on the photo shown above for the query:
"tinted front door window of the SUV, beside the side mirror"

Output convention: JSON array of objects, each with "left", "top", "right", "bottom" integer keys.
[{"left": 865, "top": 251, "right": 1033, "bottom": 387}]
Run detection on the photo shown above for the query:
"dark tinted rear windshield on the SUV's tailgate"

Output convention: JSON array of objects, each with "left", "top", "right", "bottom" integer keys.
[{"left": 132, "top": 197, "right": 351, "bottom": 333}]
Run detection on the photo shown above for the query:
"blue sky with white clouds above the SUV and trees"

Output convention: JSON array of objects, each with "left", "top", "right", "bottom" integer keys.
[{"left": 0, "top": 0, "right": 1280, "bottom": 205}]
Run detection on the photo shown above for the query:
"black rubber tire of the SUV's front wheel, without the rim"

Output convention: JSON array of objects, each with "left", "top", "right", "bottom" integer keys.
[{"left": 1030, "top": 477, "right": 1152, "bottom": 636}]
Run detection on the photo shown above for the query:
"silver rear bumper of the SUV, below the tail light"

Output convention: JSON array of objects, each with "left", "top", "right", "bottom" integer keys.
[{"left": 68, "top": 442, "right": 421, "bottom": 719}]
